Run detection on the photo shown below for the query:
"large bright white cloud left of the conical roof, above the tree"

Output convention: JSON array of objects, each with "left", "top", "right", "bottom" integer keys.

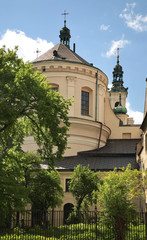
[{"left": 0, "top": 29, "right": 54, "bottom": 61}]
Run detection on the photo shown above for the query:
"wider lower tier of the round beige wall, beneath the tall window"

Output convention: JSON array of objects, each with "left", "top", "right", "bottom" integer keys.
[{"left": 65, "top": 117, "right": 111, "bottom": 156}]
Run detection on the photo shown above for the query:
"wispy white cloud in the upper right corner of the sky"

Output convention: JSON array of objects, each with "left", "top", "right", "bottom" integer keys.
[{"left": 120, "top": 3, "right": 147, "bottom": 32}]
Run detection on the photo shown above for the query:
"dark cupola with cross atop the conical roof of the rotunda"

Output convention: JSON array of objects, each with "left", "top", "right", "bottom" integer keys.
[{"left": 59, "top": 11, "right": 71, "bottom": 48}]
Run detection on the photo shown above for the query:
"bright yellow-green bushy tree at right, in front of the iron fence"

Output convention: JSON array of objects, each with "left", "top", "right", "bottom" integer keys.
[{"left": 98, "top": 166, "right": 142, "bottom": 240}]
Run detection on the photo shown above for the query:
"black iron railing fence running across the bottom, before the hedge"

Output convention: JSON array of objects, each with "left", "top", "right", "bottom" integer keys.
[{"left": 0, "top": 210, "right": 147, "bottom": 240}]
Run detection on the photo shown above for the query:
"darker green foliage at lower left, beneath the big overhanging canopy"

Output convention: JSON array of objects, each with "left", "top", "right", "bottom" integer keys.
[{"left": 0, "top": 149, "right": 41, "bottom": 226}]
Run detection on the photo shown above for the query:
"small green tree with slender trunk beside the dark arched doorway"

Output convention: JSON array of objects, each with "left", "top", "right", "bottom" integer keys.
[{"left": 69, "top": 165, "right": 100, "bottom": 211}]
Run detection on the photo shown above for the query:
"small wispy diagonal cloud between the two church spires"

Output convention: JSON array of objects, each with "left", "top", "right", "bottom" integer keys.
[{"left": 103, "top": 35, "right": 130, "bottom": 58}]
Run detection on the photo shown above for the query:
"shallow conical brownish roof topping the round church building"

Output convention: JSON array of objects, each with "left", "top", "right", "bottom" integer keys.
[{"left": 33, "top": 43, "right": 90, "bottom": 65}]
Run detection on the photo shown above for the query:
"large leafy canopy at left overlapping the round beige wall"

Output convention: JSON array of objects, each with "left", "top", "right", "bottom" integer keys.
[{"left": 0, "top": 48, "right": 71, "bottom": 166}]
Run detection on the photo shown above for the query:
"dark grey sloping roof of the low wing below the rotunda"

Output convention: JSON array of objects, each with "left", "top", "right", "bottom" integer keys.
[{"left": 56, "top": 139, "right": 139, "bottom": 171}]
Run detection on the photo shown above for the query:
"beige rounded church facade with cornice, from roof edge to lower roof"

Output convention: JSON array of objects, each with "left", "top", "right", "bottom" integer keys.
[{"left": 31, "top": 53, "right": 141, "bottom": 156}]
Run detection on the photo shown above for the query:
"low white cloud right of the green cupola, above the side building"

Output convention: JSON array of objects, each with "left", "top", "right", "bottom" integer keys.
[{"left": 126, "top": 102, "right": 143, "bottom": 124}]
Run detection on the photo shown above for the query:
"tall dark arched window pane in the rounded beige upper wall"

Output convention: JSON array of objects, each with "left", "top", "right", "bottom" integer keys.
[{"left": 81, "top": 91, "right": 89, "bottom": 116}]
